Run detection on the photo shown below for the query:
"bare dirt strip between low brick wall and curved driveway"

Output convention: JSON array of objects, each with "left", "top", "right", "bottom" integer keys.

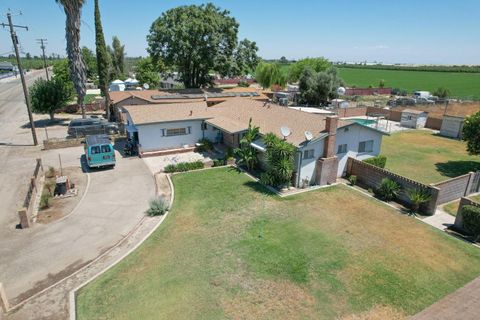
[{"left": 37, "top": 167, "right": 87, "bottom": 224}]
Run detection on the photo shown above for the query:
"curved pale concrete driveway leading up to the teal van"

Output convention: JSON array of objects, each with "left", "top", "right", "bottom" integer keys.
[{"left": 0, "top": 147, "right": 155, "bottom": 303}]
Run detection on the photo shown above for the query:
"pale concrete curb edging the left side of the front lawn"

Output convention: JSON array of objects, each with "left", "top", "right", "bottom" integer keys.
[{"left": 68, "top": 174, "right": 175, "bottom": 320}]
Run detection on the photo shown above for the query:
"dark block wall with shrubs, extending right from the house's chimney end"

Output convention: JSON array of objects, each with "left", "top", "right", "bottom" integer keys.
[{"left": 347, "top": 158, "right": 440, "bottom": 214}]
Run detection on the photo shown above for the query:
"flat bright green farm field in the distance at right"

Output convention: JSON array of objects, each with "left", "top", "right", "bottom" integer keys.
[{"left": 339, "top": 68, "right": 480, "bottom": 100}]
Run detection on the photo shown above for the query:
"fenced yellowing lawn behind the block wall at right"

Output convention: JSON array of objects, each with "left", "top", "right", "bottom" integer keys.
[{"left": 381, "top": 130, "right": 480, "bottom": 184}]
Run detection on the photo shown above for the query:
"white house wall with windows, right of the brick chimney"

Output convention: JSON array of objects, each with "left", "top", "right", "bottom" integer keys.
[{"left": 335, "top": 124, "right": 383, "bottom": 177}]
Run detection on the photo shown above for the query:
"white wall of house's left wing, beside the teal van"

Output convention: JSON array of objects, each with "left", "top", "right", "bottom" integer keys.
[{"left": 136, "top": 120, "right": 207, "bottom": 151}]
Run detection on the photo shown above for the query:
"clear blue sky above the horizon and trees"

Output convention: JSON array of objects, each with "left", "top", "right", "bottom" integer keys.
[{"left": 0, "top": 0, "right": 480, "bottom": 64}]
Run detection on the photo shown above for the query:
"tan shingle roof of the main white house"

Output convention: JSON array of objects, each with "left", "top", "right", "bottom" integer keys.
[{"left": 124, "top": 97, "right": 351, "bottom": 145}]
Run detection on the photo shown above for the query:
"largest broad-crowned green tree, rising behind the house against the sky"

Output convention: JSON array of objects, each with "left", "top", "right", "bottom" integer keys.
[{"left": 147, "top": 3, "right": 238, "bottom": 88}]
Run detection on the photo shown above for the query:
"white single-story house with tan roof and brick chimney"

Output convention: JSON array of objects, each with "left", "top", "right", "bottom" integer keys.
[{"left": 123, "top": 97, "right": 386, "bottom": 186}]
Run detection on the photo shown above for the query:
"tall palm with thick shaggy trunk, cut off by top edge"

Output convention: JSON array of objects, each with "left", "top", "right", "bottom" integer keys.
[{"left": 55, "top": 0, "right": 87, "bottom": 118}]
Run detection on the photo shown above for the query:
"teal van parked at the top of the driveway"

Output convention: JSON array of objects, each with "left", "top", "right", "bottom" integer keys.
[{"left": 85, "top": 134, "right": 115, "bottom": 168}]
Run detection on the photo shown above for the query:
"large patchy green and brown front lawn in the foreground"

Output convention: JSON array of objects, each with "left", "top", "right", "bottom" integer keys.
[{"left": 77, "top": 168, "right": 480, "bottom": 320}]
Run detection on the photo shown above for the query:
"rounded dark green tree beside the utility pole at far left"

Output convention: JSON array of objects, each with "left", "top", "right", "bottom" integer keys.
[{"left": 29, "top": 77, "right": 72, "bottom": 120}]
